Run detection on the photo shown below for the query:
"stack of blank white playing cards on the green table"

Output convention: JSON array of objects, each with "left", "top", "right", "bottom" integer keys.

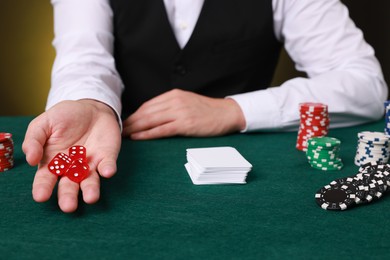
[{"left": 184, "top": 147, "right": 252, "bottom": 185}]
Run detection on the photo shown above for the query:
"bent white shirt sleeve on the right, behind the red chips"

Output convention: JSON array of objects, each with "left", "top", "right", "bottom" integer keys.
[{"left": 230, "top": 0, "right": 388, "bottom": 132}]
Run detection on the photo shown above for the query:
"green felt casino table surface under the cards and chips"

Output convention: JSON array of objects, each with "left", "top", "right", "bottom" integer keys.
[{"left": 0, "top": 117, "right": 390, "bottom": 259}]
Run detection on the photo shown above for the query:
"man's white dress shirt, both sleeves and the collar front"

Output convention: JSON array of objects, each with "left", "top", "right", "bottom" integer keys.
[{"left": 46, "top": 0, "right": 387, "bottom": 131}]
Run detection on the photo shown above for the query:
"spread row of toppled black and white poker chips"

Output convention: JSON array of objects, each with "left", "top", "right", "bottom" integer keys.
[{"left": 315, "top": 162, "right": 390, "bottom": 210}]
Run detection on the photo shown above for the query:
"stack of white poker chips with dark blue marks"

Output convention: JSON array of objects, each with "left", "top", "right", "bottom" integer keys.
[{"left": 355, "top": 131, "right": 390, "bottom": 166}]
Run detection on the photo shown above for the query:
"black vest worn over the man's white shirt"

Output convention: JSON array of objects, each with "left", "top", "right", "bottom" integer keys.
[{"left": 111, "top": 0, "right": 281, "bottom": 116}]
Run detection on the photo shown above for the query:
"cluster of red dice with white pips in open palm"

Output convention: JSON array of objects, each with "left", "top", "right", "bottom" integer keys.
[{"left": 48, "top": 145, "right": 89, "bottom": 183}]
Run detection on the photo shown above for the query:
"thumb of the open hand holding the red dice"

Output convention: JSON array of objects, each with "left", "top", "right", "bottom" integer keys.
[{"left": 22, "top": 117, "right": 48, "bottom": 166}]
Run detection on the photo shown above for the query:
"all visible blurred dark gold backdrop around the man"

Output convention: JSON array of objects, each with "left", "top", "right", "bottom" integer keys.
[{"left": 0, "top": 0, "right": 390, "bottom": 116}]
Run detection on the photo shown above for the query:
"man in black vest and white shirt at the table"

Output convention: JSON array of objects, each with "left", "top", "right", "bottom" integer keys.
[{"left": 23, "top": 0, "right": 387, "bottom": 212}]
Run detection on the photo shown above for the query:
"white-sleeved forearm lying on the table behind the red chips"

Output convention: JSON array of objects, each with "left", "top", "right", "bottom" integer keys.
[{"left": 232, "top": 71, "right": 387, "bottom": 131}]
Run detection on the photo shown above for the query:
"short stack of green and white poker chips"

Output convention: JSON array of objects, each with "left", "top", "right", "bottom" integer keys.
[{"left": 306, "top": 136, "right": 343, "bottom": 171}]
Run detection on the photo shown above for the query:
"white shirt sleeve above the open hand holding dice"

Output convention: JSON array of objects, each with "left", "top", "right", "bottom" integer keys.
[{"left": 46, "top": 0, "right": 123, "bottom": 118}]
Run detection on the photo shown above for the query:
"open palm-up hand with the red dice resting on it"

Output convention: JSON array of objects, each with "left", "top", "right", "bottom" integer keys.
[{"left": 23, "top": 100, "right": 121, "bottom": 212}]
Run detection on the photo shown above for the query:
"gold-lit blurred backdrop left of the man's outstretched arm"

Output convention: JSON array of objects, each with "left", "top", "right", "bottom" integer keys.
[{"left": 0, "top": 0, "right": 55, "bottom": 115}]
